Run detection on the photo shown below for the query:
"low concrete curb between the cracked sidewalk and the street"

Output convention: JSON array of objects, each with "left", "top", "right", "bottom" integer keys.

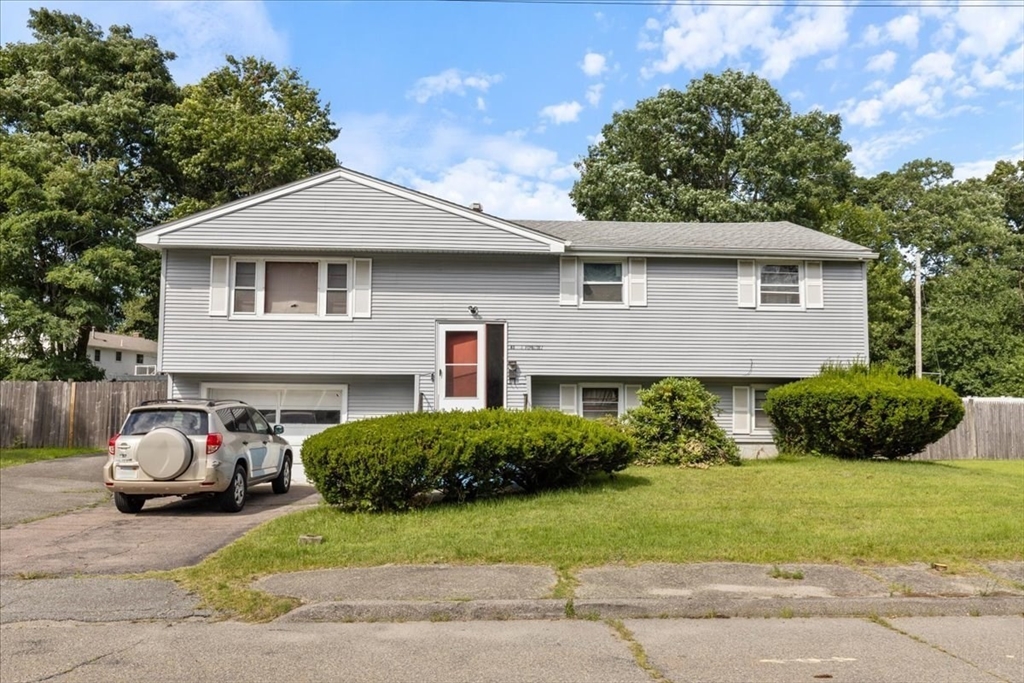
[{"left": 276, "top": 596, "right": 1024, "bottom": 623}]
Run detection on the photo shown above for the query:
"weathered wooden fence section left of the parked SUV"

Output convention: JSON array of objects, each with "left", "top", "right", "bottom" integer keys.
[{"left": 0, "top": 380, "right": 167, "bottom": 449}]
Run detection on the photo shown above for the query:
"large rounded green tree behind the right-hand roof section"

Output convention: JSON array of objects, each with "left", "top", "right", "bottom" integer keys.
[{"left": 569, "top": 70, "right": 854, "bottom": 227}]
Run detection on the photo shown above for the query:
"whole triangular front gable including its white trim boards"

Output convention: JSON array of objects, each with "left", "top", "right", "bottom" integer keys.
[{"left": 138, "top": 168, "right": 563, "bottom": 253}]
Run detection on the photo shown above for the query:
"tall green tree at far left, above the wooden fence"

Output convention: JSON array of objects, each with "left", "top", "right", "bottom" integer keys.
[{"left": 0, "top": 9, "right": 178, "bottom": 379}]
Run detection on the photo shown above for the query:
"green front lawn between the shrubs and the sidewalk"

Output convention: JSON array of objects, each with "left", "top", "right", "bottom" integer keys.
[{"left": 176, "top": 458, "right": 1024, "bottom": 620}]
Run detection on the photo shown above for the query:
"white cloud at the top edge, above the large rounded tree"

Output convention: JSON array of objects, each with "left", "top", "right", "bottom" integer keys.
[{"left": 640, "top": 4, "right": 851, "bottom": 78}]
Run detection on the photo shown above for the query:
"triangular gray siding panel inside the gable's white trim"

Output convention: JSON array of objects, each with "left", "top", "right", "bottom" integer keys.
[{"left": 154, "top": 178, "right": 550, "bottom": 253}]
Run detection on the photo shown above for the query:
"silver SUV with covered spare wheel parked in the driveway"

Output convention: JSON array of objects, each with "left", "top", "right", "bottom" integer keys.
[{"left": 103, "top": 398, "right": 292, "bottom": 513}]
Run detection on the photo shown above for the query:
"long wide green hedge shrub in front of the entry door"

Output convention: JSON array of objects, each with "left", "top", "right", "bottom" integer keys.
[{"left": 302, "top": 410, "right": 633, "bottom": 511}]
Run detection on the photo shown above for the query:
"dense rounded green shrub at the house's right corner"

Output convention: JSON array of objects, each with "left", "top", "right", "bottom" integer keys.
[{"left": 764, "top": 364, "right": 964, "bottom": 459}]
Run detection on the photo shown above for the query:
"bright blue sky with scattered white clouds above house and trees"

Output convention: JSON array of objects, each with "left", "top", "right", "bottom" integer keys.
[{"left": 0, "top": 0, "right": 1024, "bottom": 218}]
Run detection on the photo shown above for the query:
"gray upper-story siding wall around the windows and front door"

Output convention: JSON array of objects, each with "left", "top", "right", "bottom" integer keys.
[{"left": 162, "top": 250, "right": 867, "bottom": 385}]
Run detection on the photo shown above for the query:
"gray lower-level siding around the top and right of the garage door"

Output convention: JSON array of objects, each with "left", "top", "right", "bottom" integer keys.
[{"left": 171, "top": 373, "right": 414, "bottom": 420}]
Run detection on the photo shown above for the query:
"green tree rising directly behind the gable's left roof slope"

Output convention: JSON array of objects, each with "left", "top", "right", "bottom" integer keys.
[{"left": 163, "top": 56, "right": 339, "bottom": 216}]
